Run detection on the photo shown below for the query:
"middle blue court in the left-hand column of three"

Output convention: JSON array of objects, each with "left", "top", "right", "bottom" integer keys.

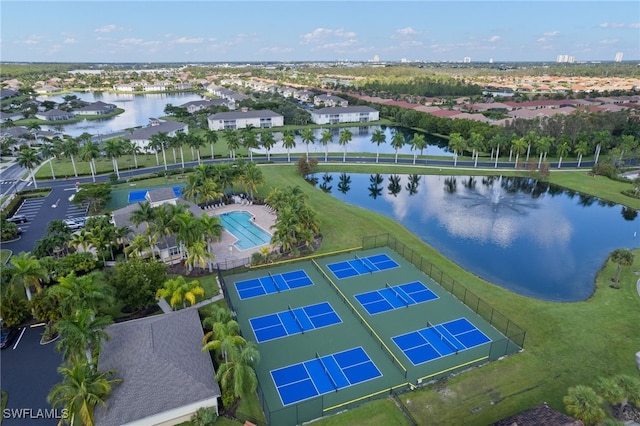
[{"left": 249, "top": 302, "right": 342, "bottom": 343}]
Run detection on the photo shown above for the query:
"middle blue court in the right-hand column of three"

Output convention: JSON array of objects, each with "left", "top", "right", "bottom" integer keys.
[{"left": 355, "top": 281, "right": 438, "bottom": 315}]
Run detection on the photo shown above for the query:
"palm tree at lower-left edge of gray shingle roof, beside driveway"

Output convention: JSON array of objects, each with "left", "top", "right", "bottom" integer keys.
[{"left": 47, "top": 363, "right": 122, "bottom": 426}]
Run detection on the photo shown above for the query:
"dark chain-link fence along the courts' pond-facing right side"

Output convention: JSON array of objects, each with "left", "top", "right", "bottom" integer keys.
[{"left": 362, "top": 234, "right": 526, "bottom": 352}]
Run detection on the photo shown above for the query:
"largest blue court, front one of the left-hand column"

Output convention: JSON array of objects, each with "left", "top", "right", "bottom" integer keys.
[{"left": 271, "top": 347, "right": 382, "bottom": 405}]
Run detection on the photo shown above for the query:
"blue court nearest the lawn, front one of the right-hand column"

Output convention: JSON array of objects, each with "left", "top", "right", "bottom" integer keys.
[{"left": 392, "top": 318, "right": 491, "bottom": 365}]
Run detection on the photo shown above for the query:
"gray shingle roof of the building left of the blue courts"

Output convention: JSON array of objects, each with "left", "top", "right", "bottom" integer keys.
[{"left": 95, "top": 308, "right": 220, "bottom": 426}]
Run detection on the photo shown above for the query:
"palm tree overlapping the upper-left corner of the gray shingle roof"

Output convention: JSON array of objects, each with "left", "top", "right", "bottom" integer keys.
[{"left": 55, "top": 309, "right": 113, "bottom": 367}]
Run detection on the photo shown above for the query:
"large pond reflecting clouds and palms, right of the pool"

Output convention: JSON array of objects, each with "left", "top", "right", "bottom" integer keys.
[{"left": 314, "top": 173, "right": 640, "bottom": 302}]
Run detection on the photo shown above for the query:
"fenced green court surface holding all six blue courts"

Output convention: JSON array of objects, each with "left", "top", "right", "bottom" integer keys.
[{"left": 223, "top": 247, "right": 521, "bottom": 425}]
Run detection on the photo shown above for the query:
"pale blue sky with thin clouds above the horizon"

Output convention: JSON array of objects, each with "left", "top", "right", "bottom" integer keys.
[{"left": 0, "top": 0, "right": 640, "bottom": 62}]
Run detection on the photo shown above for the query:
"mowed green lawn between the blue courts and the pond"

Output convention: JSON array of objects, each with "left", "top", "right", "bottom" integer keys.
[{"left": 250, "top": 166, "right": 640, "bottom": 425}]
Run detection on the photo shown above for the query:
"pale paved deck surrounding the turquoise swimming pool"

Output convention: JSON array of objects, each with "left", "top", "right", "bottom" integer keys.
[{"left": 205, "top": 204, "right": 276, "bottom": 266}]
